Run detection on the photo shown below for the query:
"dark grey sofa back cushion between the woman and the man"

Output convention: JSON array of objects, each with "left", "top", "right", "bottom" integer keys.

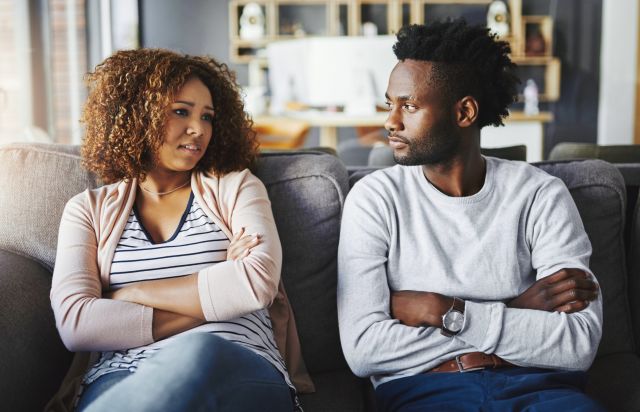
[{"left": 254, "top": 153, "right": 348, "bottom": 373}]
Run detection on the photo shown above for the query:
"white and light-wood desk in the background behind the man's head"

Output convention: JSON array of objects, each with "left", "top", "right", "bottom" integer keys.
[{"left": 254, "top": 111, "right": 553, "bottom": 162}]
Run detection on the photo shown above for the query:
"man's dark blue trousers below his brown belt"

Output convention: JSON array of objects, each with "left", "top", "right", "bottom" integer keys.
[{"left": 376, "top": 367, "right": 605, "bottom": 412}]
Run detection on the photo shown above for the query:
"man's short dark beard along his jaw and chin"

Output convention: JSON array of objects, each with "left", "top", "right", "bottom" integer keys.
[{"left": 393, "top": 118, "right": 462, "bottom": 166}]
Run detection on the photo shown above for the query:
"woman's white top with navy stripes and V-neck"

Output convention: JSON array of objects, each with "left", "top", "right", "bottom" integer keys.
[{"left": 83, "top": 193, "right": 295, "bottom": 402}]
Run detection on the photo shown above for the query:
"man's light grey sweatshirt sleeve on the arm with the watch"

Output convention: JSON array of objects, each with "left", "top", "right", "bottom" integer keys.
[{"left": 456, "top": 178, "right": 602, "bottom": 370}]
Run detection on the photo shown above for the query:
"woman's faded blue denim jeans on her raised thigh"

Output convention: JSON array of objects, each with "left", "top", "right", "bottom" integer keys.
[{"left": 77, "top": 333, "right": 293, "bottom": 412}]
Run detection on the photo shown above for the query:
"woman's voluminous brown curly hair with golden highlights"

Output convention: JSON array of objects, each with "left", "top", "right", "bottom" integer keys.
[{"left": 81, "top": 49, "right": 258, "bottom": 183}]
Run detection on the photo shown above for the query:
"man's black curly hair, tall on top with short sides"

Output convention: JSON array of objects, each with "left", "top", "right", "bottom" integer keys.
[{"left": 393, "top": 19, "right": 520, "bottom": 129}]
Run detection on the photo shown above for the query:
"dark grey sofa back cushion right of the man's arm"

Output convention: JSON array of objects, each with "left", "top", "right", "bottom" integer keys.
[{"left": 537, "top": 160, "right": 633, "bottom": 356}]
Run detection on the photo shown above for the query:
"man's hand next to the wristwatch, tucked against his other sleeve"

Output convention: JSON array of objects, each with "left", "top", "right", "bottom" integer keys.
[{"left": 391, "top": 290, "right": 453, "bottom": 328}]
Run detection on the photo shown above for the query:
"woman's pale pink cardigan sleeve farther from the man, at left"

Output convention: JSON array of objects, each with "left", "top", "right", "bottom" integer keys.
[{"left": 50, "top": 192, "right": 153, "bottom": 351}]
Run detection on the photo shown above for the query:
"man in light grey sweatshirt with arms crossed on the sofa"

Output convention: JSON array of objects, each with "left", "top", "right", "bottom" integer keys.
[{"left": 338, "top": 20, "right": 602, "bottom": 411}]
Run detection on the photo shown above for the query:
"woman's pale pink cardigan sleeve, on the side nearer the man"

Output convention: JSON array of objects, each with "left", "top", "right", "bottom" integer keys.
[{"left": 198, "top": 170, "right": 282, "bottom": 321}]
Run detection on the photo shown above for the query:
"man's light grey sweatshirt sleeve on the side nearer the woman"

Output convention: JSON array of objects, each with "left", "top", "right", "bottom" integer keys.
[{"left": 338, "top": 181, "right": 475, "bottom": 377}]
